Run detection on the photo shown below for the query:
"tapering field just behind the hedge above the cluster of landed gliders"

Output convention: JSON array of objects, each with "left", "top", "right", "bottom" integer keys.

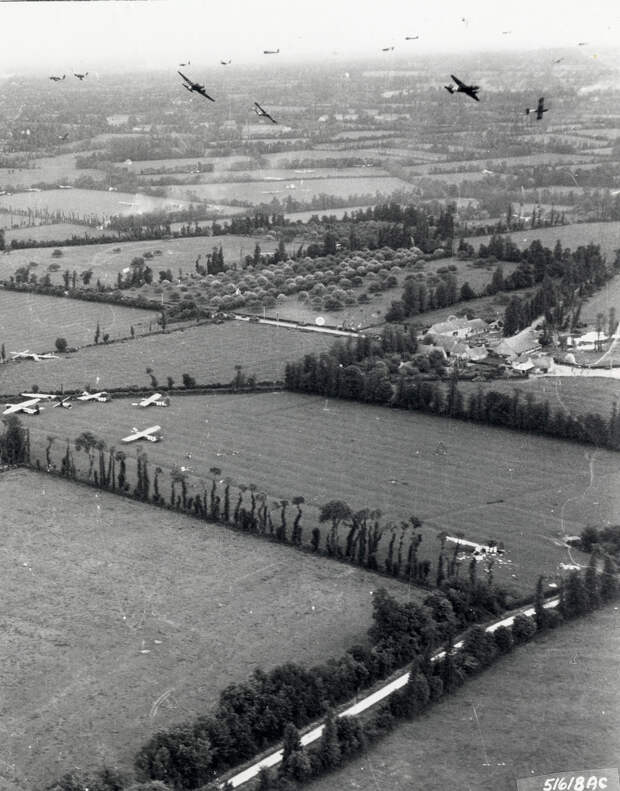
[{"left": 0, "top": 320, "right": 334, "bottom": 393}]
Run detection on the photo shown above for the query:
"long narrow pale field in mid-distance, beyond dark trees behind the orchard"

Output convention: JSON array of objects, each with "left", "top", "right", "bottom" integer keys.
[{"left": 163, "top": 176, "right": 409, "bottom": 203}]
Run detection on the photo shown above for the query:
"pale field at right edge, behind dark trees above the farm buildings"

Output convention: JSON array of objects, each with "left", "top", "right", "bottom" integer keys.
[{"left": 466, "top": 222, "right": 620, "bottom": 263}]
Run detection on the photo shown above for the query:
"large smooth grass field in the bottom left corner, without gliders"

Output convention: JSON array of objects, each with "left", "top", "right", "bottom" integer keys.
[{"left": 0, "top": 470, "right": 417, "bottom": 791}]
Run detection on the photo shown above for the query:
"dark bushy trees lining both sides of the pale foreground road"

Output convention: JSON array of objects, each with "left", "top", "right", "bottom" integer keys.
[{"left": 46, "top": 556, "right": 618, "bottom": 791}]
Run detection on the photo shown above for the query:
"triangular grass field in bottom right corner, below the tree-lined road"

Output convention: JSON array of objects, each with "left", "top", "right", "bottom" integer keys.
[{"left": 308, "top": 607, "right": 620, "bottom": 791}]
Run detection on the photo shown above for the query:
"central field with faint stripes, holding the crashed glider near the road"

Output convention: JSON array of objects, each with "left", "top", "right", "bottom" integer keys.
[{"left": 27, "top": 390, "right": 620, "bottom": 593}]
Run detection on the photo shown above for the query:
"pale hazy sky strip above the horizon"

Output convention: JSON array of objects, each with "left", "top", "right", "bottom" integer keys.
[{"left": 0, "top": 0, "right": 620, "bottom": 75}]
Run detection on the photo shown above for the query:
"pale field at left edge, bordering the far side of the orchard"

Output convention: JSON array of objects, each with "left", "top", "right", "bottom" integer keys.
[{"left": 0, "top": 234, "right": 280, "bottom": 293}]
